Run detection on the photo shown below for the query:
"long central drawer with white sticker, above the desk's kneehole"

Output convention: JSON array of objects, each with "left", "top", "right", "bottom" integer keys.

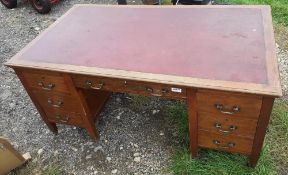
[{"left": 72, "top": 75, "right": 186, "bottom": 99}]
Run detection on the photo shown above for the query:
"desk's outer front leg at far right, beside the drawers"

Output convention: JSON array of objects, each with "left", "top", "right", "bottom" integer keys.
[{"left": 248, "top": 97, "right": 274, "bottom": 168}]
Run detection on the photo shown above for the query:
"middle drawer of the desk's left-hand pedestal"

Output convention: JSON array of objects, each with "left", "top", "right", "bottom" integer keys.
[{"left": 33, "top": 91, "right": 84, "bottom": 114}]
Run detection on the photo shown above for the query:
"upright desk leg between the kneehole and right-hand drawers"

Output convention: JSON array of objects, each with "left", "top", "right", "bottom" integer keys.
[{"left": 187, "top": 89, "right": 198, "bottom": 157}]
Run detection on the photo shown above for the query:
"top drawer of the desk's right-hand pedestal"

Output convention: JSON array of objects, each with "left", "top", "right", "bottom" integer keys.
[{"left": 196, "top": 91, "right": 262, "bottom": 119}]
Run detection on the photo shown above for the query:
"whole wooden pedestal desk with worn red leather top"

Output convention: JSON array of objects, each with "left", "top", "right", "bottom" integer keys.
[{"left": 6, "top": 5, "right": 281, "bottom": 167}]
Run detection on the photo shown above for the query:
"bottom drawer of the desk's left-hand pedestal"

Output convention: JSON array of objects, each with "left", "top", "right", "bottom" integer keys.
[{"left": 44, "top": 108, "right": 84, "bottom": 127}]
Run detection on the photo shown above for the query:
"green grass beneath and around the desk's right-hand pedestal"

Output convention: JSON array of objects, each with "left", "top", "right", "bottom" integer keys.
[{"left": 167, "top": 103, "right": 277, "bottom": 175}]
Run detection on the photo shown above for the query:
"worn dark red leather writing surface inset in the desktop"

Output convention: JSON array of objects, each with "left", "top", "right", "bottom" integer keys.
[{"left": 20, "top": 6, "right": 267, "bottom": 84}]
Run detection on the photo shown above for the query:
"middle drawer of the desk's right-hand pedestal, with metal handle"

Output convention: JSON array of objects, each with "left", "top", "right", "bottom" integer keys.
[{"left": 198, "top": 112, "right": 257, "bottom": 139}]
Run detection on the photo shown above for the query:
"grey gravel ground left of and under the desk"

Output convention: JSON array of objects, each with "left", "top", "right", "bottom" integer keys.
[{"left": 0, "top": 0, "right": 288, "bottom": 174}]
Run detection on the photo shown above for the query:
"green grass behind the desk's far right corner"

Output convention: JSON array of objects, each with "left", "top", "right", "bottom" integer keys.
[{"left": 215, "top": 0, "right": 288, "bottom": 26}]
